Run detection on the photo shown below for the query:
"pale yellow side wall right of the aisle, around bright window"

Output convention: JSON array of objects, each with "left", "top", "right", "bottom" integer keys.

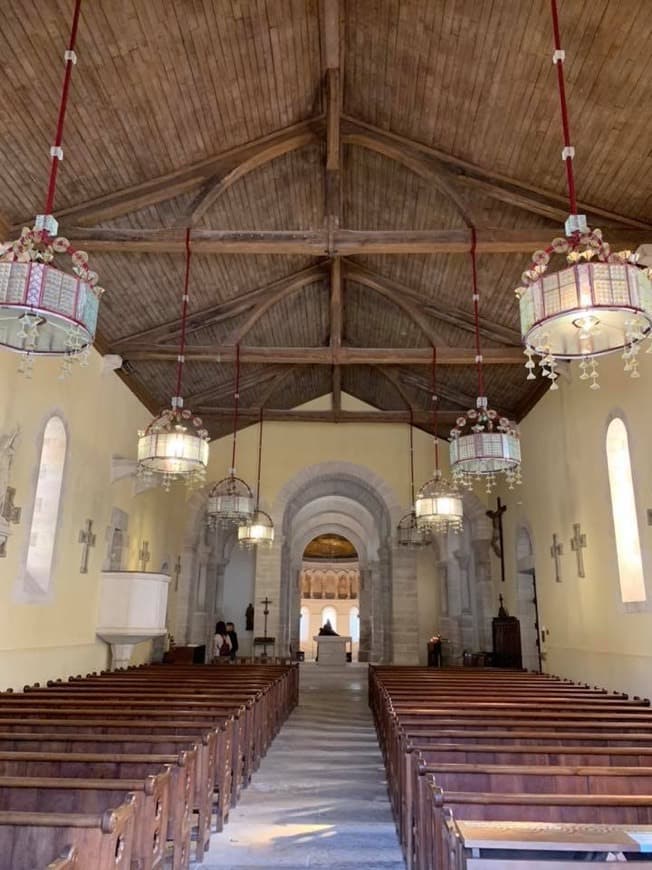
[{"left": 502, "top": 354, "right": 652, "bottom": 697}]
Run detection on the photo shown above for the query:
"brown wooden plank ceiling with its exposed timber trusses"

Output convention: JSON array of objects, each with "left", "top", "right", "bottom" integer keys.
[{"left": 0, "top": 0, "right": 652, "bottom": 436}]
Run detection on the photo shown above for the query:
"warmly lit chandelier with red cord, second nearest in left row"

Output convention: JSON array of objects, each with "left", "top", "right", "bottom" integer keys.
[{"left": 138, "top": 229, "right": 209, "bottom": 490}]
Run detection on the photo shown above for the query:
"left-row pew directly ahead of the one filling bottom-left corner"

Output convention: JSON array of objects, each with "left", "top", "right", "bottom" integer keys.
[{"left": 0, "top": 769, "right": 170, "bottom": 870}]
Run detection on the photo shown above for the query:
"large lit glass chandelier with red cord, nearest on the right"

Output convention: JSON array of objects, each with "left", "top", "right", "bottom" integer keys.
[{"left": 516, "top": 0, "right": 652, "bottom": 390}]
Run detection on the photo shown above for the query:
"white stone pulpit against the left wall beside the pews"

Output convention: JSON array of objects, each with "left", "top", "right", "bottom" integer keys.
[{"left": 96, "top": 571, "right": 170, "bottom": 670}]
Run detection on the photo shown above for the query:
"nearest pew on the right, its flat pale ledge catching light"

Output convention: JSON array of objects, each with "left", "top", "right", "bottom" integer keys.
[{"left": 443, "top": 810, "right": 652, "bottom": 870}]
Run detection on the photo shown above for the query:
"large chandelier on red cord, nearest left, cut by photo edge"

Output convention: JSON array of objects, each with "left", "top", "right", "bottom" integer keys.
[{"left": 0, "top": 0, "right": 104, "bottom": 377}]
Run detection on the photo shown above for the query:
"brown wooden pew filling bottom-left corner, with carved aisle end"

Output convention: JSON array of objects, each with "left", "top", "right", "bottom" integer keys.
[{"left": 0, "top": 796, "right": 134, "bottom": 870}]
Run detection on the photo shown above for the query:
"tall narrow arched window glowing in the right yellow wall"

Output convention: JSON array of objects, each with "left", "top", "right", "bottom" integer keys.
[{"left": 607, "top": 417, "right": 646, "bottom": 604}]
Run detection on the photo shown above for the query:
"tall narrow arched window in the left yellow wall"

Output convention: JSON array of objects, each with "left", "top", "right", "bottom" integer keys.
[{"left": 25, "top": 417, "right": 67, "bottom": 595}]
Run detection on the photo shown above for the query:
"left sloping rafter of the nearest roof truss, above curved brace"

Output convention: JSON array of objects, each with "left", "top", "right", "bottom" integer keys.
[{"left": 11, "top": 115, "right": 324, "bottom": 232}]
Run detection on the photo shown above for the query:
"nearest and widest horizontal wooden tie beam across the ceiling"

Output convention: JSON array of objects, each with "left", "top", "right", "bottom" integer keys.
[{"left": 61, "top": 227, "right": 652, "bottom": 257}]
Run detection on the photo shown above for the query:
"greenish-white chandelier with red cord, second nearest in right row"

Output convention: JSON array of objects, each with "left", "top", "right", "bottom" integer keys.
[{"left": 450, "top": 235, "right": 521, "bottom": 492}]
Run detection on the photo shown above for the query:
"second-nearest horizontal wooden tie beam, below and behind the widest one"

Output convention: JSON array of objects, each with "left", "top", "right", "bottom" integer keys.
[{"left": 125, "top": 344, "right": 524, "bottom": 366}]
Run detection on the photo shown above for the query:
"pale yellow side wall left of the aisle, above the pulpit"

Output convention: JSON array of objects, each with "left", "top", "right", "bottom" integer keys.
[{"left": 0, "top": 352, "right": 185, "bottom": 688}]
